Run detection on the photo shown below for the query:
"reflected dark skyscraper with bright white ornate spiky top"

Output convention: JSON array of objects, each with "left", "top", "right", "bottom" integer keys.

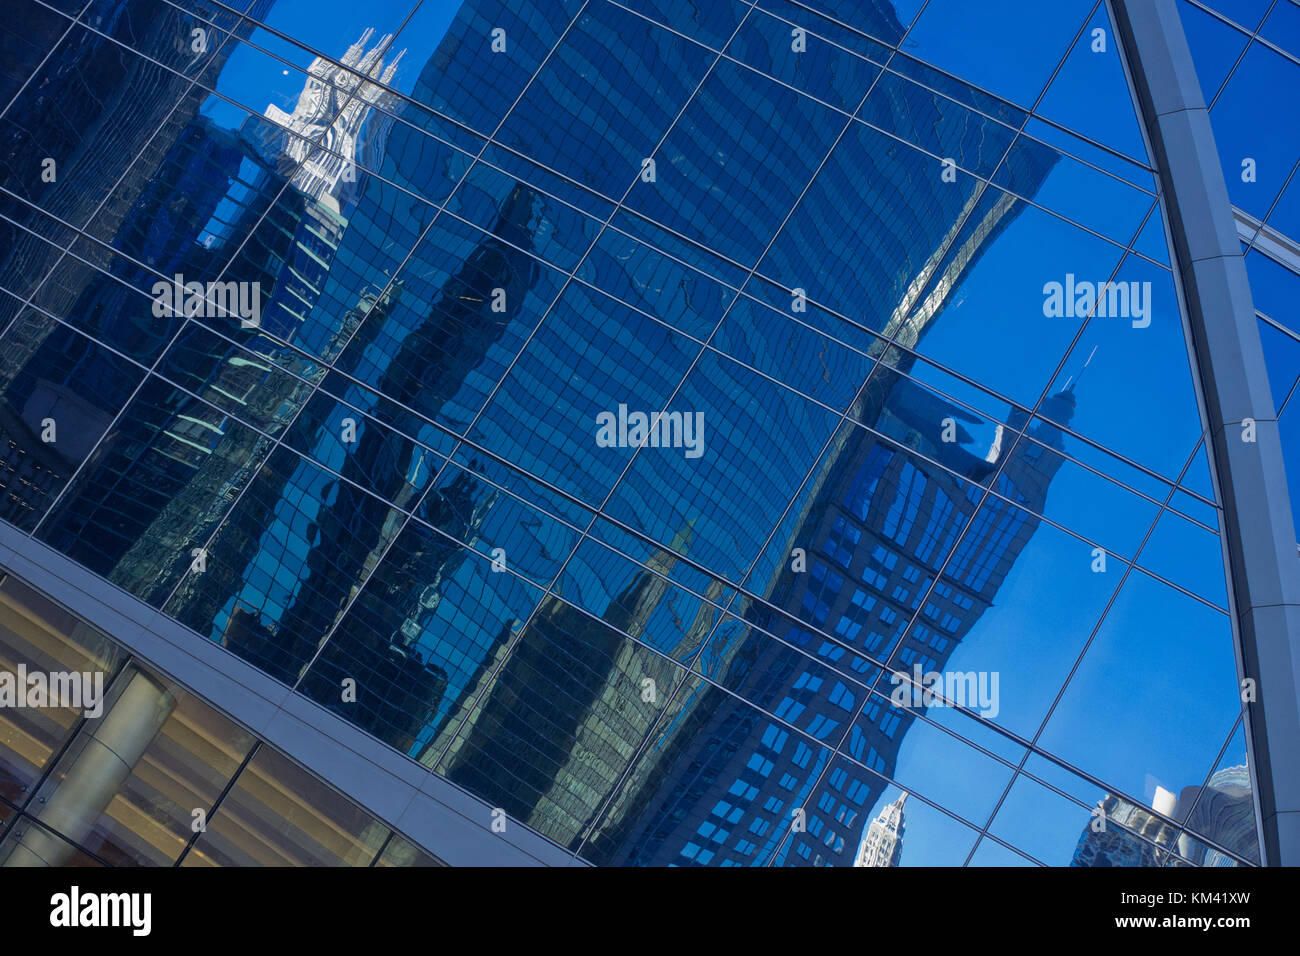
[{"left": 34, "top": 29, "right": 410, "bottom": 601}]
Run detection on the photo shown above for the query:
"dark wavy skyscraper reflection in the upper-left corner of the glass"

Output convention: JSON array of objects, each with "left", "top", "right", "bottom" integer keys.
[{"left": 0, "top": 0, "right": 270, "bottom": 529}]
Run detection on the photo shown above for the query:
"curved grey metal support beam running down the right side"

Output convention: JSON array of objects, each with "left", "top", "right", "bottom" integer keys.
[{"left": 1112, "top": 0, "right": 1300, "bottom": 866}]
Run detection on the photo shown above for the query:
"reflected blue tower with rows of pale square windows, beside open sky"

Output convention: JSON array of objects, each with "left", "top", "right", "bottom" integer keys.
[{"left": 582, "top": 125, "right": 1075, "bottom": 865}]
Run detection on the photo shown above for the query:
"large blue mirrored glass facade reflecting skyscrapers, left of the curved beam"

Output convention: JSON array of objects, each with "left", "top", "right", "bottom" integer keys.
[{"left": 0, "top": 0, "right": 1258, "bottom": 865}]
